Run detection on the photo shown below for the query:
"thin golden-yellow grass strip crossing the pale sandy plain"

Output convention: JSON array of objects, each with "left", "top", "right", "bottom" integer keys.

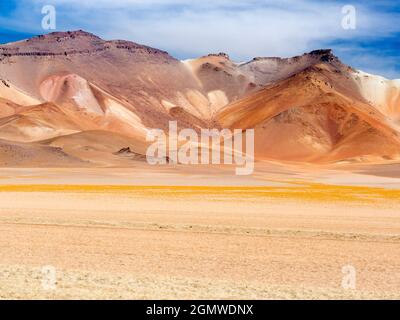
[{"left": 0, "top": 183, "right": 400, "bottom": 203}]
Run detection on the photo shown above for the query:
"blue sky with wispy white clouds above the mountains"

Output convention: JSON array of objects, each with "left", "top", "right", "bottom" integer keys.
[{"left": 0, "top": 0, "right": 400, "bottom": 79}]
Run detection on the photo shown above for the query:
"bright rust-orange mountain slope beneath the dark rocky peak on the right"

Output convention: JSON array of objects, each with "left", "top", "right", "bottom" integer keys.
[{"left": 217, "top": 64, "right": 400, "bottom": 162}]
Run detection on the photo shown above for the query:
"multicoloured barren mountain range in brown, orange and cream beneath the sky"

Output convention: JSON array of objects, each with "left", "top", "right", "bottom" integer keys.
[{"left": 0, "top": 30, "right": 400, "bottom": 167}]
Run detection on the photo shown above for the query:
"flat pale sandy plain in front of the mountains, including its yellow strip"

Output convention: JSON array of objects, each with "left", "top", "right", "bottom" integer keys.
[{"left": 0, "top": 165, "right": 400, "bottom": 299}]
